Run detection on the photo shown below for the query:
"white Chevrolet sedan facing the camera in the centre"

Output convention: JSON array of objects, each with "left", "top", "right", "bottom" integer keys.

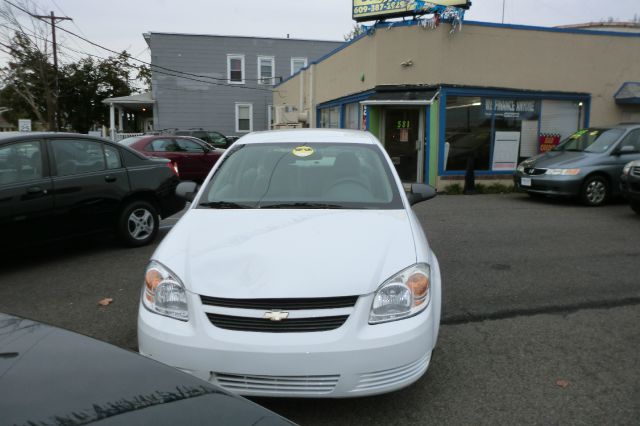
[{"left": 138, "top": 130, "right": 441, "bottom": 398}]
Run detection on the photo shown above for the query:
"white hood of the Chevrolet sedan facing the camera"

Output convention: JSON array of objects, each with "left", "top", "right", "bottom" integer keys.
[{"left": 153, "top": 209, "right": 416, "bottom": 299}]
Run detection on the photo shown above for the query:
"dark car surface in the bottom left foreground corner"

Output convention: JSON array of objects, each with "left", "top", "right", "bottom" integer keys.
[{"left": 0, "top": 313, "right": 291, "bottom": 426}]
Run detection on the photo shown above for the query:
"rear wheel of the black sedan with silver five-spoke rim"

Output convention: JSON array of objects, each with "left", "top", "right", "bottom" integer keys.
[{"left": 117, "top": 200, "right": 160, "bottom": 247}]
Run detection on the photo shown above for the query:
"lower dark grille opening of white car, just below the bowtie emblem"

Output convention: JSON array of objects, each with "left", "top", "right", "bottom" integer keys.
[{"left": 207, "top": 312, "right": 349, "bottom": 333}]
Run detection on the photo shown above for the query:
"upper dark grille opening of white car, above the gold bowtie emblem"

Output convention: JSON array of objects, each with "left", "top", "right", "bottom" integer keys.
[{"left": 200, "top": 296, "right": 358, "bottom": 311}]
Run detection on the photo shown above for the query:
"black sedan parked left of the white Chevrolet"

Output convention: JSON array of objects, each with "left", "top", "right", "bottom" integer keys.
[{"left": 0, "top": 133, "right": 185, "bottom": 248}]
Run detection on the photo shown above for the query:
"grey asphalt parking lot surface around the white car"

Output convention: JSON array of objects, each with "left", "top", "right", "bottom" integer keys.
[{"left": 0, "top": 194, "right": 640, "bottom": 425}]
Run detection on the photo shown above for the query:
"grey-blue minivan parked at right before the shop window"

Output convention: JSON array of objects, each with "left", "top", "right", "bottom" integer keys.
[{"left": 514, "top": 124, "right": 640, "bottom": 206}]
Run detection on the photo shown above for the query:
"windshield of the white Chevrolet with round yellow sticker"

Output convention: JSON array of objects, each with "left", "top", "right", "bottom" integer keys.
[{"left": 199, "top": 143, "right": 402, "bottom": 209}]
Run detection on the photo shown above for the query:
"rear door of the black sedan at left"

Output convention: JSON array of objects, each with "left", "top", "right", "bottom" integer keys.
[{"left": 49, "top": 137, "right": 129, "bottom": 235}]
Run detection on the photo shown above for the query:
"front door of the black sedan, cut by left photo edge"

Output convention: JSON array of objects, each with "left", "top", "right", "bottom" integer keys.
[{"left": 0, "top": 140, "right": 55, "bottom": 249}]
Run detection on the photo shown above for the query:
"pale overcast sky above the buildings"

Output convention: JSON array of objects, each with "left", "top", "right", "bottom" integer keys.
[{"left": 0, "top": 0, "right": 640, "bottom": 61}]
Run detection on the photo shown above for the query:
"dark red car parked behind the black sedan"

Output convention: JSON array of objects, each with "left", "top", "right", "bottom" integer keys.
[{"left": 120, "top": 135, "right": 224, "bottom": 182}]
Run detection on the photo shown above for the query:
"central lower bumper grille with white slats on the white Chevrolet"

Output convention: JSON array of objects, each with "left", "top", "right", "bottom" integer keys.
[{"left": 215, "top": 373, "right": 340, "bottom": 395}]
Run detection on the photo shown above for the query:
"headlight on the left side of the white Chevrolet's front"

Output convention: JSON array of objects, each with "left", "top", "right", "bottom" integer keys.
[{"left": 142, "top": 260, "right": 189, "bottom": 321}]
